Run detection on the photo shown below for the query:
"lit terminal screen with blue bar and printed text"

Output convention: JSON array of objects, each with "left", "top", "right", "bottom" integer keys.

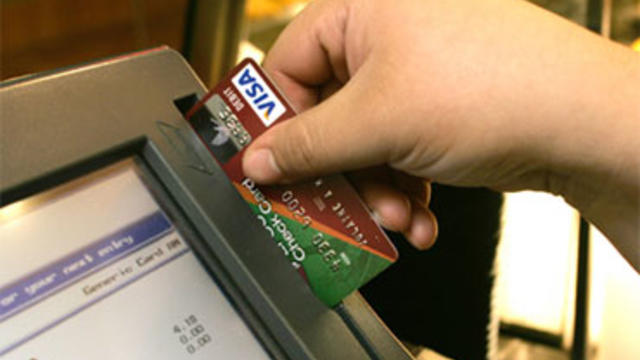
[{"left": 0, "top": 160, "right": 269, "bottom": 359}]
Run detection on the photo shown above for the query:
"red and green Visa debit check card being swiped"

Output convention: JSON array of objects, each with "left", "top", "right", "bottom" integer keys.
[{"left": 186, "top": 59, "right": 398, "bottom": 306}]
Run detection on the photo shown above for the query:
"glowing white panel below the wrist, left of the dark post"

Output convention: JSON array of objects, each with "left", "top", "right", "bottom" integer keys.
[{"left": 496, "top": 192, "right": 579, "bottom": 338}]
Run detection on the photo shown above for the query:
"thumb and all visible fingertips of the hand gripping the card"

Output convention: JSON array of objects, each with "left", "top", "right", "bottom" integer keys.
[{"left": 255, "top": 0, "right": 438, "bottom": 253}]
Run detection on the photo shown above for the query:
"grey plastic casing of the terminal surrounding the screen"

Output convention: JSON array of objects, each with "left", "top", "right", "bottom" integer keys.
[{"left": 0, "top": 47, "right": 411, "bottom": 359}]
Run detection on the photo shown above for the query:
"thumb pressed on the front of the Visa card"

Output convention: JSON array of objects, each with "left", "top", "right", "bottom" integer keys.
[{"left": 243, "top": 77, "right": 393, "bottom": 184}]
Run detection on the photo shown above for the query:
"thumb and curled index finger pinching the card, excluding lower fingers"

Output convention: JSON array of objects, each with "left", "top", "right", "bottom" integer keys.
[{"left": 249, "top": 0, "right": 394, "bottom": 184}]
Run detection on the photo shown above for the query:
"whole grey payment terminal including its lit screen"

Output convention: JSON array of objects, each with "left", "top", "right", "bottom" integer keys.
[{"left": 0, "top": 47, "right": 411, "bottom": 359}]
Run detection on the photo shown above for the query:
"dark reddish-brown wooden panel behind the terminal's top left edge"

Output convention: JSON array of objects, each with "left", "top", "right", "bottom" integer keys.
[{"left": 0, "top": 0, "right": 188, "bottom": 79}]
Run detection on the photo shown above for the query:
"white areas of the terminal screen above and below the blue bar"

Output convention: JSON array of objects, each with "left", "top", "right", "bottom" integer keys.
[{"left": 0, "top": 161, "right": 268, "bottom": 359}]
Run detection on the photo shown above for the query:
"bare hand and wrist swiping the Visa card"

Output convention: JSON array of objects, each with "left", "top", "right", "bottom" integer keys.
[{"left": 243, "top": 0, "right": 640, "bottom": 266}]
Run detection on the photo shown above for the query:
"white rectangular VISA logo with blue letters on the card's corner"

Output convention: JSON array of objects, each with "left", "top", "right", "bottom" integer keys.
[{"left": 231, "top": 63, "right": 286, "bottom": 127}]
